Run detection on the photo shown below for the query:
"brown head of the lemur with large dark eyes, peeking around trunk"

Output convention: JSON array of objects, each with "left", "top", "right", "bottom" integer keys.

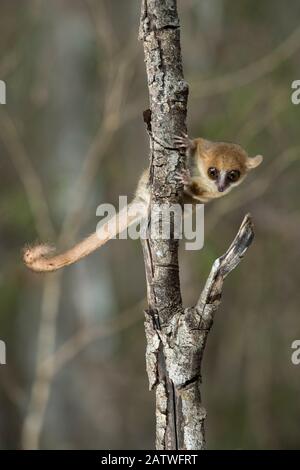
[{"left": 200, "top": 141, "right": 263, "bottom": 193}]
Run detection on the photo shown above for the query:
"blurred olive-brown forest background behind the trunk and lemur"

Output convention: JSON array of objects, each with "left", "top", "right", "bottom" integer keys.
[{"left": 0, "top": 0, "right": 300, "bottom": 449}]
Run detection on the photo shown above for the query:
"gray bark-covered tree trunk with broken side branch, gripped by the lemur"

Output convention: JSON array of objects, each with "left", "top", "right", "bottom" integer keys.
[{"left": 140, "top": 0, "right": 253, "bottom": 450}]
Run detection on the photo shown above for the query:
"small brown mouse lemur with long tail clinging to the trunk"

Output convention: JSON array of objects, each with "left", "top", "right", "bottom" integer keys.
[{"left": 23, "top": 135, "right": 263, "bottom": 272}]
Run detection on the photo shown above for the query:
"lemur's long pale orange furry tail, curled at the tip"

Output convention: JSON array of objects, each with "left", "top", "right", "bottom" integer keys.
[{"left": 23, "top": 199, "right": 147, "bottom": 272}]
